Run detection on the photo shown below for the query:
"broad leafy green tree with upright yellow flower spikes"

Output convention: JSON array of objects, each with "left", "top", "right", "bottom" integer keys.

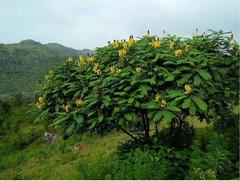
[{"left": 33, "top": 30, "right": 239, "bottom": 146}]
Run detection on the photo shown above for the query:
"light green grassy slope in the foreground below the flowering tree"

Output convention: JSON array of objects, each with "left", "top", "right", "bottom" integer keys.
[{"left": 0, "top": 113, "right": 210, "bottom": 180}]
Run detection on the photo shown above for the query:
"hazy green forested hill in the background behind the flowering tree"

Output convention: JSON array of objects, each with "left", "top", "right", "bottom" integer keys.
[{"left": 0, "top": 40, "right": 94, "bottom": 97}]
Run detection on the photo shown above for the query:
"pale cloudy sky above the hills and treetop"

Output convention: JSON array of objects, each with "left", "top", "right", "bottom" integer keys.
[{"left": 0, "top": 0, "right": 239, "bottom": 50}]
